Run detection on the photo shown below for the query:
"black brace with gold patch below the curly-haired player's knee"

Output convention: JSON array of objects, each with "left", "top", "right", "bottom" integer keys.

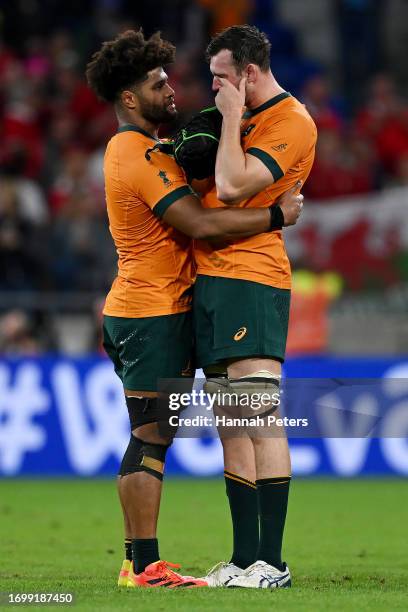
[{"left": 119, "top": 435, "right": 171, "bottom": 480}]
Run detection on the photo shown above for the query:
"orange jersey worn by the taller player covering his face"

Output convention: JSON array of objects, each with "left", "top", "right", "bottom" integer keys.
[{"left": 194, "top": 92, "right": 316, "bottom": 289}]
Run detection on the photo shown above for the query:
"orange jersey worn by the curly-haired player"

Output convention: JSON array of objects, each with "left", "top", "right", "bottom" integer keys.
[{"left": 103, "top": 125, "right": 194, "bottom": 318}]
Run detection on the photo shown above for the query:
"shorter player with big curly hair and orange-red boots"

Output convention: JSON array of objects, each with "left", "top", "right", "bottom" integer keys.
[{"left": 86, "top": 30, "right": 301, "bottom": 588}]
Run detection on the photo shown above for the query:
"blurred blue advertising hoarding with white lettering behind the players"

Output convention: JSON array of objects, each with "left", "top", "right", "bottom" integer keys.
[{"left": 0, "top": 356, "right": 408, "bottom": 477}]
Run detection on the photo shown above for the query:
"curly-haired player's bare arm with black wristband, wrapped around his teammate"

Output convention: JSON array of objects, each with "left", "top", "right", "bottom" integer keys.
[{"left": 162, "top": 185, "right": 303, "bottom": 239}]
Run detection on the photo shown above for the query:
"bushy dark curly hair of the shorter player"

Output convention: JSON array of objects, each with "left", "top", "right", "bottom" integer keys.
[{"left": 85, "top": 29, "right": 176, "bottom": 102}]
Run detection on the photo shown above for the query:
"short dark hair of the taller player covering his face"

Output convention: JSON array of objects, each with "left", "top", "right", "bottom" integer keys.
[{"left": 206, "top": 25, "right": 271, "bottom": 72}]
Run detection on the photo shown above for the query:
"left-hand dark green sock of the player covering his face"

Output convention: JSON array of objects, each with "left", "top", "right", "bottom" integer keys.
[{"left": 224, "top": 472, "right": 259, "bottom": 569}]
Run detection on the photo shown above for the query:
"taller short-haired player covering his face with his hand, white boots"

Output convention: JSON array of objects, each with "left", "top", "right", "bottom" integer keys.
[{"left": 194, "top": 25, "right": 316, "bottom": 588}]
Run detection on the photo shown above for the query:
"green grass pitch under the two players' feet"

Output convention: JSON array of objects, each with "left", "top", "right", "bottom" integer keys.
[{"left": 0, "top": 479, "right": 408, "bottom": 612}]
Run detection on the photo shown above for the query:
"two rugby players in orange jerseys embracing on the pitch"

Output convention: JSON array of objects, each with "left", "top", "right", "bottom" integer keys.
[{"left": 87, "top": 26, "right": 316, "bottom": 588}]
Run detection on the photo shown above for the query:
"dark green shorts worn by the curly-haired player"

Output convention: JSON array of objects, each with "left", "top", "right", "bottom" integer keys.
[{"left": 104, "top": 312, "right": 193, "bottom": 392}]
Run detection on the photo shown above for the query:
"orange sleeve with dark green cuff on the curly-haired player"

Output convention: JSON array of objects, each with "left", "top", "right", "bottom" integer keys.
[{"left": 137, "top": 152, "right": 194, "bottom": 217}]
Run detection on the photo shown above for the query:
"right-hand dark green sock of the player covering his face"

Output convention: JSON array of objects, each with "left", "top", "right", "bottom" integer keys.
[{"left": 256, "top": 476, "right": 290, "bottom": 571}]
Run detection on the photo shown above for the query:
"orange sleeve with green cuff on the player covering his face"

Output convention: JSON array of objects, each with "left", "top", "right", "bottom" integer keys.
[{"left": 246, "top": 116, "right": 309, "bottom": 182}]
